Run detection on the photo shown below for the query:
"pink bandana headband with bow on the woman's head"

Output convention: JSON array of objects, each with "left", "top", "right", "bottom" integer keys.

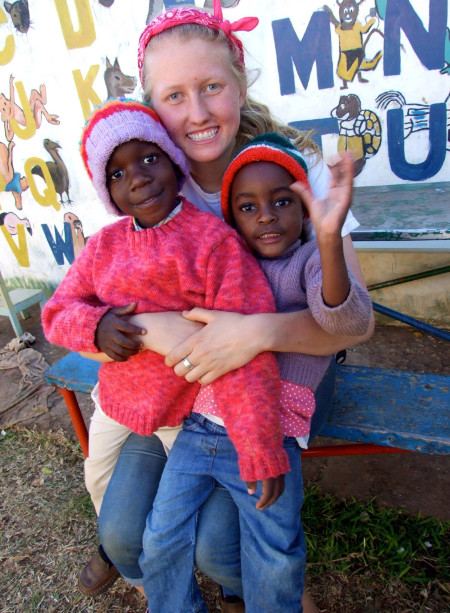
[{"left": 138, "top": 0, "right": 259, "bottom": 85}]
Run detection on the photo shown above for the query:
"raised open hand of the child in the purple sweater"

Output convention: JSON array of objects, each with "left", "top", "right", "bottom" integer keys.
[{"left": 291, "top": 152, "right": 353, "bottom": 241}]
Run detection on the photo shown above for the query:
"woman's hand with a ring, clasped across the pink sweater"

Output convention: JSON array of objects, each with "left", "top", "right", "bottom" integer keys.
[{"left": 166, "top": 308, "right": 265, "bottom": 385}]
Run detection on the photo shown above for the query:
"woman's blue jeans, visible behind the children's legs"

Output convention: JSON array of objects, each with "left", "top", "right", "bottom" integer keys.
[{"left": 99, "top": 359, "right": 335, "bottom": 597}]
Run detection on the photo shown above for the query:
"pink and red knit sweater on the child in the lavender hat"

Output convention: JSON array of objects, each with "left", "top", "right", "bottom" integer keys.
[{"left": 42, "top": 201, "right": 289, "bottom": 481}]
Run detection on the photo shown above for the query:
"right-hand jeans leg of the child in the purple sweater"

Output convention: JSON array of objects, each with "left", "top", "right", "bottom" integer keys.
[{"left": 213, "top": 437, "right": 306, "bottom": 613}]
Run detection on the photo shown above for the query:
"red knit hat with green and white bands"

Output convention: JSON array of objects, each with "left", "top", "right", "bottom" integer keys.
[{"left": 221, "top": 132, "right": 308, "bottom": 225}]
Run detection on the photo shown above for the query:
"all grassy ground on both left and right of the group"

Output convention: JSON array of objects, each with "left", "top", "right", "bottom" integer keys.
[{"left": 0, "top": 427, "right": 450, "bottom": 613}]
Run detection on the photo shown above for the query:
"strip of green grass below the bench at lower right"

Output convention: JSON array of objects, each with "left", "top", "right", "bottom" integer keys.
[{"left": 302, "top": 488, "right": 450, "bottom": 583}]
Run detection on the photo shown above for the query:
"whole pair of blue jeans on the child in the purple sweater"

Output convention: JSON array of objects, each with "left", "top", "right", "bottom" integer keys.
[{"left": 140, "top": 413, "right": 306, "bottom": 613}]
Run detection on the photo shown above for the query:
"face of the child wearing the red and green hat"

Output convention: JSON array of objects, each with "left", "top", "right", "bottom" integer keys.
[{"left": 231, "top": 162, "right": 303, "bottom": 258}]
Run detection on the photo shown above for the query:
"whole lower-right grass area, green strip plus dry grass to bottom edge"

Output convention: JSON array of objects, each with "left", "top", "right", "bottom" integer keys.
[{"left": 302, "top": 487, "right": 450, "bottom": 613}]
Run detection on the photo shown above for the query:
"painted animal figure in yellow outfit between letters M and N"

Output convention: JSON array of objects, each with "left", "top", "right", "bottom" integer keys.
[{"left": 323, "top": 0, "right": 384, "bottom": 89}]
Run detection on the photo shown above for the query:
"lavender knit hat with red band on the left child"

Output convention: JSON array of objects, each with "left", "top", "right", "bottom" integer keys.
[{"left": 80, "top": 98, "right": 189, "bottom": 215}]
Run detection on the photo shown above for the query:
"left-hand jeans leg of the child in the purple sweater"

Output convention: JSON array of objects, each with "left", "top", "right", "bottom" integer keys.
[{"left": 139, "top": 418, "right": 225, "bottom": 613}]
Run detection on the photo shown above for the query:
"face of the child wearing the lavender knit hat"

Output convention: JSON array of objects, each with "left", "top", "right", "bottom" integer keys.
[{"left": 106, "top": 140, "right": 178, "bottom": 228}]
